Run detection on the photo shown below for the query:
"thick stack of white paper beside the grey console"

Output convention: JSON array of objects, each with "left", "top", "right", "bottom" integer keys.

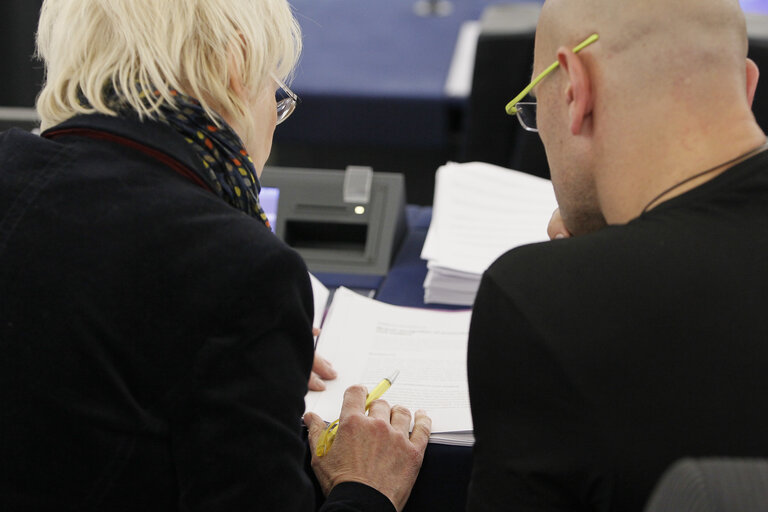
[{"left": 421, "top": 162, "right": 557, "bottom": 306}]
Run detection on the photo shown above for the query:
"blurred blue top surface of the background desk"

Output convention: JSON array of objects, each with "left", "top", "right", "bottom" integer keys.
[{"left": 291, "top": 0, "right": 499, "bottom": 99}]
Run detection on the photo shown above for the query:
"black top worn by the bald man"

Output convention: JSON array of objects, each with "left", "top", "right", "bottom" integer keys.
[{"left": 468, "top": 152, "right": 768, "bottom": 512}]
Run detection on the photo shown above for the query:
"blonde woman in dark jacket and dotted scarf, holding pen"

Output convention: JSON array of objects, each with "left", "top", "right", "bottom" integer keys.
[{"left": 0, "top": 0, "right": 429, "bottom": 512}]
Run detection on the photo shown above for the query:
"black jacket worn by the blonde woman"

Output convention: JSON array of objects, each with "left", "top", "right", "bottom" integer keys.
[{"left": 0, "top": 115, "right": 391, "bottom": 512}]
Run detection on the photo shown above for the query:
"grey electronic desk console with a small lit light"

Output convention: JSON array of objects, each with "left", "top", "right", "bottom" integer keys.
[{"left": 260, "top": 167, "right": 405, "bottom": 284}]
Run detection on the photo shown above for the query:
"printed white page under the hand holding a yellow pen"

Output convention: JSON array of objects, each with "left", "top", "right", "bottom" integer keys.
[{"left": 306, "top": 288, "right": 472, "bottom": 432}]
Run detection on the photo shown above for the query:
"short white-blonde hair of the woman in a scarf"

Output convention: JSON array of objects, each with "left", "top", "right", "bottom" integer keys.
[{"left": 37, "top": 0, "right": 301, "bottom": 129}]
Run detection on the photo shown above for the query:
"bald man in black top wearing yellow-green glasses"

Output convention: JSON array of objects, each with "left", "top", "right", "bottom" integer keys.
[{"left": 468, "top": 0, "right": 768, "bottom": 512}]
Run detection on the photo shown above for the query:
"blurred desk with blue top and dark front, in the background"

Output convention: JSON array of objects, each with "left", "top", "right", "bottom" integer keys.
[{"left": 275, "top": 0, "right": 535, "bottom": 147}]
